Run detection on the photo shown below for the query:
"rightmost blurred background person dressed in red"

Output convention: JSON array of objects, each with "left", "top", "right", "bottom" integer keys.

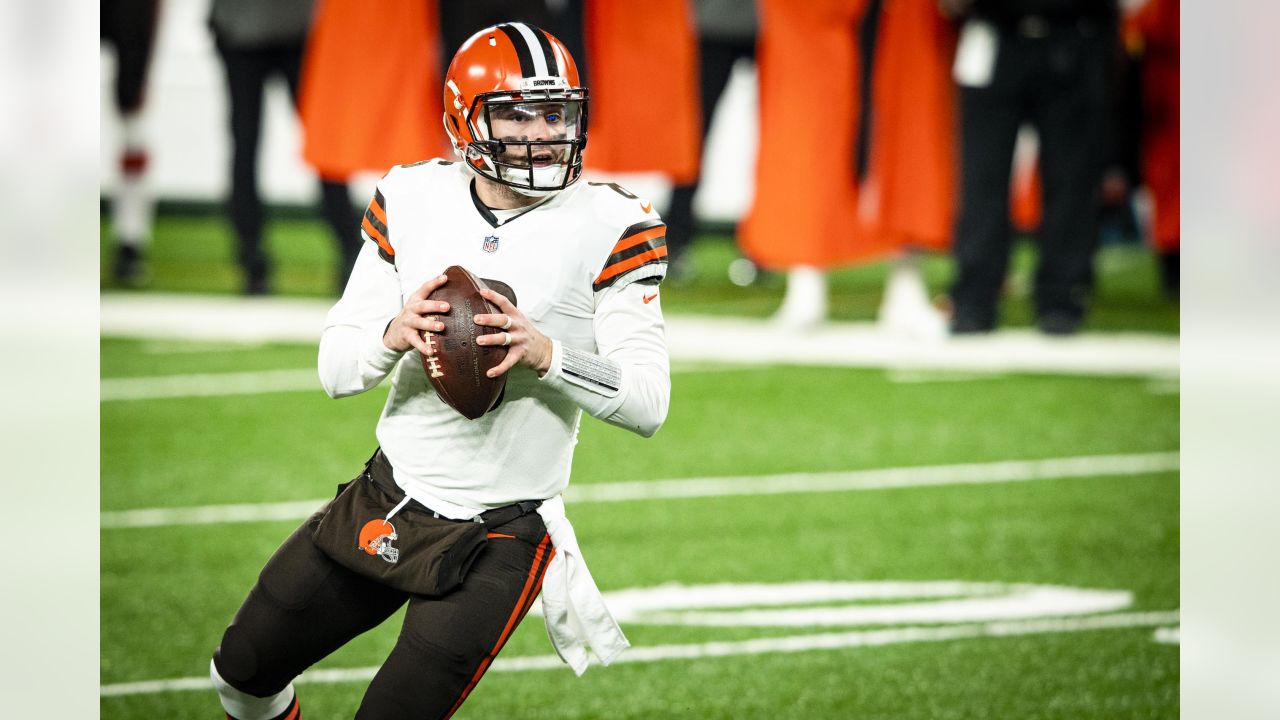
[{"left": 1125, "top": 0, "right": 1181, "bottom": 299}]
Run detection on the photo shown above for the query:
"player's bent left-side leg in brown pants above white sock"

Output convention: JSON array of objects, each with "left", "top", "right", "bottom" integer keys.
[{"left": 210, "top": 523, "right": 407, "bottom": 720}]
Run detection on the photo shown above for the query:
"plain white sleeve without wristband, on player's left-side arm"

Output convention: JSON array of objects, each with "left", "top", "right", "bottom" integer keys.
[{"left": 319, "top": 242, "right": 404, "bottom": 397}]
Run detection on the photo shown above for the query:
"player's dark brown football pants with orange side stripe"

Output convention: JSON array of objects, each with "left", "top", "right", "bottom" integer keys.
[{"left": 214, "top": 512, "right": 554, "bottom": 720}]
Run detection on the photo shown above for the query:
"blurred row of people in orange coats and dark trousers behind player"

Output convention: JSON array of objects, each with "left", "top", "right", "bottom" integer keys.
[{"left": 101, "top": 0, "right": 1180, "bottom": 336}]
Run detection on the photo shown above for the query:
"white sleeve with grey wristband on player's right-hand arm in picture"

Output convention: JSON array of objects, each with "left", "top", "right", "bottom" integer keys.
[{"left": 541, "top": 282, "right": 671, "bottom": 437}]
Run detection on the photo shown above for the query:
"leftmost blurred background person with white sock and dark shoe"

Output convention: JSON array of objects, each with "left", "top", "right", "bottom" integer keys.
[{"left": 99, "top": 0, "right": 160, "bottom": 286}]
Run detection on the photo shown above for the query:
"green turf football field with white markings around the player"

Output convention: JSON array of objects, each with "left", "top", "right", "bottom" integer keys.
[{"left": 100, "top": 220, "right": 1180, "bottom": 720}]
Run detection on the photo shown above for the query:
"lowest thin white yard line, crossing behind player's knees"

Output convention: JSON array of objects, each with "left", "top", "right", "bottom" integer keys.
[{"left": 99, "top": 610, "right": 1179, "bottom": 697}]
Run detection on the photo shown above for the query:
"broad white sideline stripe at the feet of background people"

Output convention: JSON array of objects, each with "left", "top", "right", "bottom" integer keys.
[{"left": 100, "top": 292, "right": 1179, "bottom": 377}]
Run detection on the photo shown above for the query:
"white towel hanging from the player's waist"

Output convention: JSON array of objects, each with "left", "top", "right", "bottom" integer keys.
[{"left": 538, "top": 496, "right": 631, "bottom": 675}]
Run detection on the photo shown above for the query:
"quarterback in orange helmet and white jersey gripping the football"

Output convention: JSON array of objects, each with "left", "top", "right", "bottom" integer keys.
[{"left": 210, "top": 23, "right": 671, "bottom": 720}]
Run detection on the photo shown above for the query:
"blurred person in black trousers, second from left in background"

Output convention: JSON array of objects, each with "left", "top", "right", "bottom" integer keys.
[{"left": 209, "top": 0, "right": 358, "bottom": 295}]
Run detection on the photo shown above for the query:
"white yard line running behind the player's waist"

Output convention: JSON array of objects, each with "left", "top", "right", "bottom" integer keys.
[{"left": 100, "top": 452, "right": 1179, "bottom": 529}]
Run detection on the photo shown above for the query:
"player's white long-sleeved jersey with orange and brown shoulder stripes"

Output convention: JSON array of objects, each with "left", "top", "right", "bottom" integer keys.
[{"left": 320, "top": 160, "right": 671, "bottom": 519}]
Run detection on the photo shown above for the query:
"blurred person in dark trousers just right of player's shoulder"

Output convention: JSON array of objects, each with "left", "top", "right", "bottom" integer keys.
[{"left": 663, "top": 0, "right": 759, "bottom": 282}]
